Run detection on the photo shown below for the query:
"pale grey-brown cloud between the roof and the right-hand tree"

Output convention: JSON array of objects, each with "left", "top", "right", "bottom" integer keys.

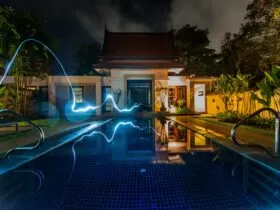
[{"left": 170, "top": 0, "right": 252, "bottom": 50}]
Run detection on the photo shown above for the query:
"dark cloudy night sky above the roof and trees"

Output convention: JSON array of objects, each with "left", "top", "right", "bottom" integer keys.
[{"left": 0, "top": 0, "right": 251, "bottom": 71}]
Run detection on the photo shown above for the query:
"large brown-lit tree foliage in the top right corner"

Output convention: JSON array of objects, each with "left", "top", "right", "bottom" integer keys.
[{"left": 222, "top": 0, "right": 280, "bottom": 79}]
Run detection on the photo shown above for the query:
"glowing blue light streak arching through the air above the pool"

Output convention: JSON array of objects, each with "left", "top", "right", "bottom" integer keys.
[{"left": 0, "top": 39, "right": 142, "bottom": 113}]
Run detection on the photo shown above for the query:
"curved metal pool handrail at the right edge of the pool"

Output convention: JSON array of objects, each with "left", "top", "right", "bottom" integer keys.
[{"left": 231, "top": 108, "right": 280, "bottom": 157}]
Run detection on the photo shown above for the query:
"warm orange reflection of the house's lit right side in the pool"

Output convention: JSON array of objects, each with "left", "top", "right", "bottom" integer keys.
[{"left": 155, "top": 121, "right": 213, "bottom": 163}]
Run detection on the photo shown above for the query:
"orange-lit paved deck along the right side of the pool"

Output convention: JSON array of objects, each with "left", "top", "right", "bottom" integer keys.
[{"left": 167, "top": 116, "right": 280, "bottom": 175}]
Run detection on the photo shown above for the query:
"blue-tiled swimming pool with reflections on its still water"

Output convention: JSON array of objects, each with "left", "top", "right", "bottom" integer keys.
[{"left": 0, "top": 118, "right": 276, "bottom": 210}]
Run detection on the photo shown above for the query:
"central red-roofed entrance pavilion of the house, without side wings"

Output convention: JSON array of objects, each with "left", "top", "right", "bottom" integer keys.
[{"left": 93, "top": 29, "right": 185, "bottom": 111}]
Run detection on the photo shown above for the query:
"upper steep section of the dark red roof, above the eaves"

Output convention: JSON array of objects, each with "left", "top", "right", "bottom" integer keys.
[{"left": 103, "top": 30, "right": 175, "bottom": 59}]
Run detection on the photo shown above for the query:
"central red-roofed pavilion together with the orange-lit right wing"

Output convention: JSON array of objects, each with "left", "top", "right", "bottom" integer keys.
[{"left": 93, "top": 29, "right": 213, "bottom": 113}]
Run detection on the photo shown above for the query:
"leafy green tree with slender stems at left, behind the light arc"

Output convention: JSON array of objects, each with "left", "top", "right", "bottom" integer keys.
[{"left": 0, "top": 7, "right": 55, "bottom": 115}]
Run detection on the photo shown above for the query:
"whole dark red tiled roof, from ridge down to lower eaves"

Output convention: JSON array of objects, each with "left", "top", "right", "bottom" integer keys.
[{"left": 93, "top": 29, "right": 186, "bottom": 69}]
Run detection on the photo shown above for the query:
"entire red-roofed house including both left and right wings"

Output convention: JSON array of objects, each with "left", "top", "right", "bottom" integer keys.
[{"left": 0, "top": 29, "right": 215, "bottom": 115}]
